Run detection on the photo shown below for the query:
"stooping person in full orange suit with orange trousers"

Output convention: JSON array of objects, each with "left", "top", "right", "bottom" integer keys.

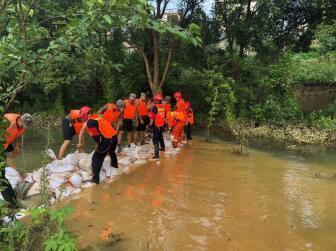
[{"left": 169, "top": 111, "right": 185, "bottom": 148}]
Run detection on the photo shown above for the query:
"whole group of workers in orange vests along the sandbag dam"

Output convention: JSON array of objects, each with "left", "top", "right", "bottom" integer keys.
[{"left": 2, "top": 92, "right": 194, "bottom": 207}]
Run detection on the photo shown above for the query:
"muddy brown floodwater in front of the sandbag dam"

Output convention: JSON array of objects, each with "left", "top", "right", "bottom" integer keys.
[{"left": 13, "top": 128, "right": 336, "bottom": 251}]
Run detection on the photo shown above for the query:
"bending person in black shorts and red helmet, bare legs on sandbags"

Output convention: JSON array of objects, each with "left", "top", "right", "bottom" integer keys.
[{"left": 58, "top": 106, "right": 91, "bottom": 159}]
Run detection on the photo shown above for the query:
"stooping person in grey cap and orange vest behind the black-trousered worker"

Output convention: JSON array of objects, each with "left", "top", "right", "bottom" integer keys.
[{"left": 98, "top": 99, "right": 125, "bottom": 128}]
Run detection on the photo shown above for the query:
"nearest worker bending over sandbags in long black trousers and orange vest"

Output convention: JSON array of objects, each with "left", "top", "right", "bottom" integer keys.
[{"left": 77, "top": 114, "right": 118, "bottom": 184}]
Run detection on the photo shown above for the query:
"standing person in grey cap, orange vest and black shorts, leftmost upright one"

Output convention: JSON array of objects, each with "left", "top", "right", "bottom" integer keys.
[{"left": 118, "top": 93, "right": 138, "bottom": 152}]
